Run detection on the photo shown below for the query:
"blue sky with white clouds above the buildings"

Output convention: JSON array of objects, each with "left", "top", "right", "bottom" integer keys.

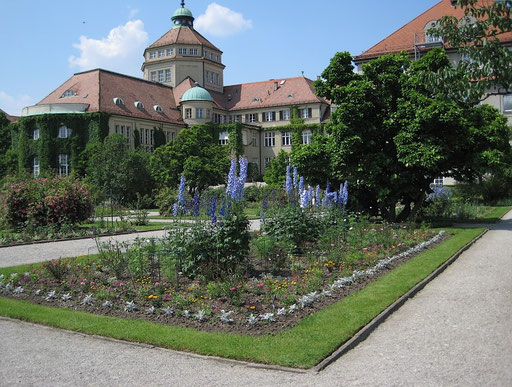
[{"left": 0, "top": 0, "right": 440, "bottom": 115}]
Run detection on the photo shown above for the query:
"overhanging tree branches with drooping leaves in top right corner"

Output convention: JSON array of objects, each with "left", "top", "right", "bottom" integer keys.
[{"left": 429, "top": 0, "right": 512, "bottom": 100}]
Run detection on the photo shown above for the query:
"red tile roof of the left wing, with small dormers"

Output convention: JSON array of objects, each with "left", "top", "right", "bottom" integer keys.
[{"left": 38, "top": 69, "right": 184, "bottom": 125}]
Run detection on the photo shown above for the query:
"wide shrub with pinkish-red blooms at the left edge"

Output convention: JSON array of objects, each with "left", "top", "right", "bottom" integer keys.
[{"left": 0, "top": 177, "right": 93, "bottom": 229}]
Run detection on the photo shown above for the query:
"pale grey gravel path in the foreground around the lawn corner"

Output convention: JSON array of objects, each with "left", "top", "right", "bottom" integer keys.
[{"left": 0, "top": 212, "right": 512, "bottom": 386}]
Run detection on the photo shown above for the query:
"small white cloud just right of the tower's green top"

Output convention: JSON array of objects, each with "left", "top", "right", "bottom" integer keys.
[{"left": 194, "top": 3, "right": 252, "bottom": 37}]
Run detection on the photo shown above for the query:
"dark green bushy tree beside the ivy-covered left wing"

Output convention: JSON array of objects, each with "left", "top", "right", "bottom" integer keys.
[{"left": 87, "top": 134, "right": 154, "bottom": 204}]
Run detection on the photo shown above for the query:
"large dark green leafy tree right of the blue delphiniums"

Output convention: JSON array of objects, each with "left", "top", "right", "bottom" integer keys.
[{"left": 317, "top": 50, "right": 510, "bottom": 221}]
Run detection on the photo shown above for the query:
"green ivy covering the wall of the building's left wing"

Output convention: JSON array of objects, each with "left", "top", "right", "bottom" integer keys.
[{"left": 14, "top": 113, "right": 109, "bottom": 176}]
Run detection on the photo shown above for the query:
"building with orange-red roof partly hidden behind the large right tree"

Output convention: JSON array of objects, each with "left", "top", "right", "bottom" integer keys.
[{"left": 354, "top": 0, "right": 512, "bottom": 125}]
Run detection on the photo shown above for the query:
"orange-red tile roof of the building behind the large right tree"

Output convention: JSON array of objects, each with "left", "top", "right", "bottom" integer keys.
[{"left": 354, "top": 0, "right": 512, "bottom": 62}]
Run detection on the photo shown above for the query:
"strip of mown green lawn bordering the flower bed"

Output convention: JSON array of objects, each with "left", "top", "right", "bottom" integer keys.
[{"left": 0, "top": 228, "right": 484, "bottom": 368}]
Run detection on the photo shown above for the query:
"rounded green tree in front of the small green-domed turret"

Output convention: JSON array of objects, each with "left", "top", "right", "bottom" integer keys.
[{"left": 151, "top": 125, "right": 230, "bottom": 192}]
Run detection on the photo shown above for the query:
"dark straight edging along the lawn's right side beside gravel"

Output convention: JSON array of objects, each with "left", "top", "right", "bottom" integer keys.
[{"left": 310, "top": 229, "right": 489, "bottom": 373}]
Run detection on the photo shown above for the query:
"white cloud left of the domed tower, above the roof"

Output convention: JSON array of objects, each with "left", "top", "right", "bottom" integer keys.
[{"left": 68, "top": 20, "right": 148, "bottom": 75}]
